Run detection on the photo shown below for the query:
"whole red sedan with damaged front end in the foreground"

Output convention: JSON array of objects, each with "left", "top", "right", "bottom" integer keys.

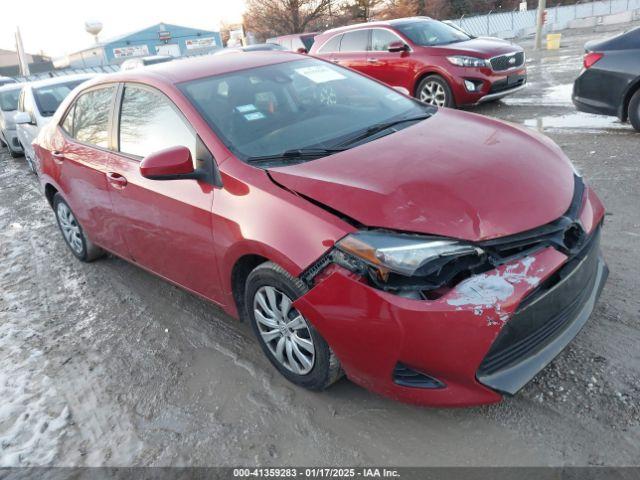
[{"left": 35, "top": 52, "right": 607, "bottom": 405}]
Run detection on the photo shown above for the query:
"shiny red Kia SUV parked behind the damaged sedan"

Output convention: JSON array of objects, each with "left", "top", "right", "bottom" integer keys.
[{"left": 310, "top": 17, "right": 527, "bottom": 107}]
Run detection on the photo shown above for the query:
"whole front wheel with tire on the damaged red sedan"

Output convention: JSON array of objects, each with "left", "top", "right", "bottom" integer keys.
[{"left": 245, "top": 262, "right": 342, "bottom": 390}]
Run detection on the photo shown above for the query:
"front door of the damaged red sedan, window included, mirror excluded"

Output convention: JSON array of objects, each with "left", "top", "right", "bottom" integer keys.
[{"left": 107, "top": 84, "right": 220, "bottom": 299}]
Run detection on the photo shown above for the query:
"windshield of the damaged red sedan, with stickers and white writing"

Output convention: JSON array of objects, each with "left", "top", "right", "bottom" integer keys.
[{"left": 180, "top": 59, "right": 426, "bottom": 160}]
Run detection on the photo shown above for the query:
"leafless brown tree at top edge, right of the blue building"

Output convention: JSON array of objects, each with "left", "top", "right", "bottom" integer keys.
[{"left": 244, "top": 0, "right": 331, "bottom": 39}]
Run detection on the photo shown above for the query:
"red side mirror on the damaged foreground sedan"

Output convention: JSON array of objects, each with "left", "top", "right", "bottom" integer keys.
[{"left": 140, "top": 146, "right": 201, "bottom": 180}]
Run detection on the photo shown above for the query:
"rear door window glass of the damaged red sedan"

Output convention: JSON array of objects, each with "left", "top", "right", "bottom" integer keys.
[{"left": 72, "top": 86, "right": 116, "bottom": 148}]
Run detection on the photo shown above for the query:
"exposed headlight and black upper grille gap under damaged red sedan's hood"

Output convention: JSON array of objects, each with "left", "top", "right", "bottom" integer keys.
[{"left": 301, "top": 176, "right": 587, "bottom": 300}]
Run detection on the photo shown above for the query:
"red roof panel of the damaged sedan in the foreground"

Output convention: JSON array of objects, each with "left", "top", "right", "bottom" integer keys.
[{"left": 83, "top": 50, "right": 309, "bottom": 84}]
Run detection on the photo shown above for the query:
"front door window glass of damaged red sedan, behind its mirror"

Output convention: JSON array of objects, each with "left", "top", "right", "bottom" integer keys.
[{"left": 119, "top": 85, "right": 197, "bottom": 161}]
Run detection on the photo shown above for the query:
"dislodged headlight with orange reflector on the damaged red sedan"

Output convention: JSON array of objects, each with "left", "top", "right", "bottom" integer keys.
[{"left": 336, "top": 231, "right": 485, "bottom": 289}]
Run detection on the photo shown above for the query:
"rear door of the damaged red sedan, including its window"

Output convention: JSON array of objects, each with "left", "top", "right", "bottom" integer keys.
[{"left": 55, "top": 84, "right": 119, "bottom": 254}]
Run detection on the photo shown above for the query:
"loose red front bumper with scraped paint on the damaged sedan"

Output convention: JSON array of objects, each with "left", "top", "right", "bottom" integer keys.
[{"left": 294, "top": 188, "right": 607, "bottom": 406}]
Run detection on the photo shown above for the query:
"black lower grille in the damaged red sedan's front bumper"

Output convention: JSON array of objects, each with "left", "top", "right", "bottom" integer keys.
[{"left": 478, "top": 230, "right": 600, "bottom": 377}]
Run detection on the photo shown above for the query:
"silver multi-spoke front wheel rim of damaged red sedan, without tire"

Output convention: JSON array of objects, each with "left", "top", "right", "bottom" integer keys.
[{"left": 253, "top": 286, "right": 315, "bottom": 375}]
